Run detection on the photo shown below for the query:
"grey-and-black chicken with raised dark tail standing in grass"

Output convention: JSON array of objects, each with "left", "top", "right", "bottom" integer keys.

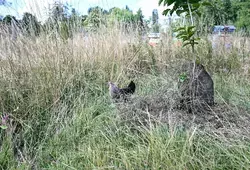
[{"left": 108, "top": 81, "right": 136, "bottom": 100}]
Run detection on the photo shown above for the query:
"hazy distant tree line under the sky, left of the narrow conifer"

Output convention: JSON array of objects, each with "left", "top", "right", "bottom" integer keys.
[{"left": 0, "top": 1, "right": 146, "bottom": 39}]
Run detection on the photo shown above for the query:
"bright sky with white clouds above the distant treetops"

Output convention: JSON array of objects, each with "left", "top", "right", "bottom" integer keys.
[{"left": 0, "top": 0, "right": 170, "bottom": 21}]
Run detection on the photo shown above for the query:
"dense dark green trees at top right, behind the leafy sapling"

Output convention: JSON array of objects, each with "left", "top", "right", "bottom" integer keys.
[{"left": 196, "top": 0, "right": 250, "bottom": 32}]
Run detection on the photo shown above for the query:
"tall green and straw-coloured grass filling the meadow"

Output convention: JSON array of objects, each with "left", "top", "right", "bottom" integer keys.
[{"left": 0, "top": 24, "right": 250, "bottom": 169}]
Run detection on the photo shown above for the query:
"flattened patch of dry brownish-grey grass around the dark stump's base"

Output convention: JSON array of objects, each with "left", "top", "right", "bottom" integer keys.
[{"left": 117, "top": 94, "right": 250, "bottom": 138}]
